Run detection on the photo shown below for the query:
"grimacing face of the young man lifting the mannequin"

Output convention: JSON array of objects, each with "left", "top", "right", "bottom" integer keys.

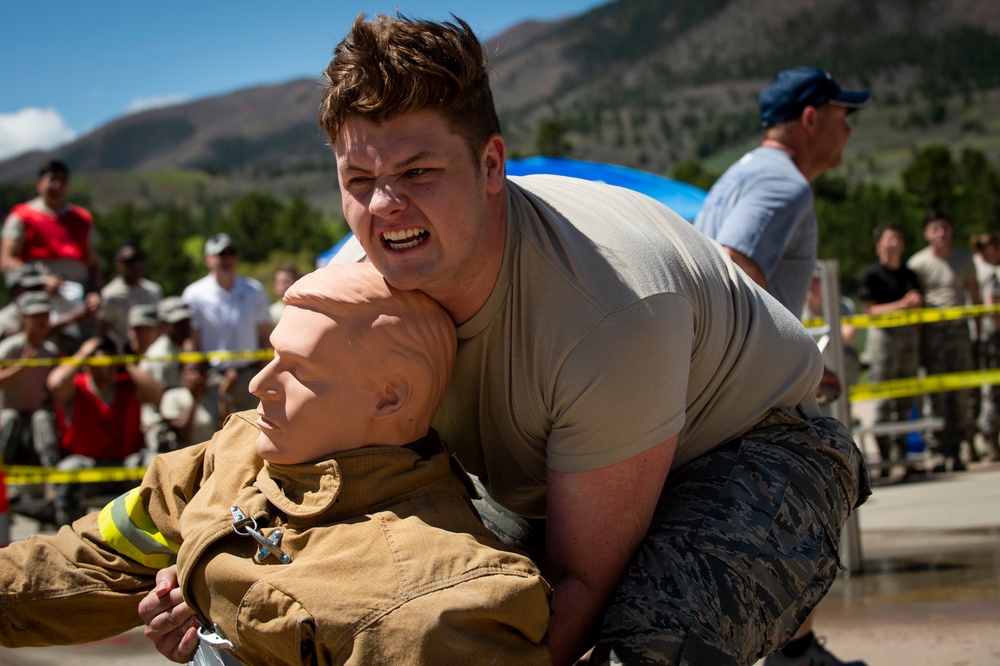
[{"left": 334, "top": 111, "right": 503, "bottom": 308}]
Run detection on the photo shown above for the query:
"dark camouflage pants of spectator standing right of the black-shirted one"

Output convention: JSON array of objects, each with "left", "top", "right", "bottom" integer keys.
[{"left": 920, "top": 320, "right": 975, "bottom": 457}]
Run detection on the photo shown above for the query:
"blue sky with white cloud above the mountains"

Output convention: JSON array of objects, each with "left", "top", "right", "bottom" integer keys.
[{"left": 0, "top": 0, "right": 608, "bottom": 159}]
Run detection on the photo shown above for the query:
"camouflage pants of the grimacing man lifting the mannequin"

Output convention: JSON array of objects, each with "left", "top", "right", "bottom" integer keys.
[{"left": 477, "top": 411, "right": 870, "bottom": 666}]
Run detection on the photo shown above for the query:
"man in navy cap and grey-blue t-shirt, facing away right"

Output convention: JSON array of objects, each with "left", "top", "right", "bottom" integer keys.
[{"left": 695, "top": 67, "right": 871, "bottom": 666}]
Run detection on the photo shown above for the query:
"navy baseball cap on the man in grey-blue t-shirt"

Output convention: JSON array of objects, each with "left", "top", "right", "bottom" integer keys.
[{"left": 760, "top": 67, "right": 872, "bottom": 128}]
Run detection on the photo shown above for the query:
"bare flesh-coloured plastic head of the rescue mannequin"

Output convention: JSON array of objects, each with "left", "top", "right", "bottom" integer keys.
[{"left": 250, "top": 264, "right": 456, "bottom": 464}]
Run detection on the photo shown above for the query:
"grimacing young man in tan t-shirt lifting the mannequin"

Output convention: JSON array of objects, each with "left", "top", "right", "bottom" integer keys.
[{"left": 140, "top": 17, "right": 867, "bottom": 665}]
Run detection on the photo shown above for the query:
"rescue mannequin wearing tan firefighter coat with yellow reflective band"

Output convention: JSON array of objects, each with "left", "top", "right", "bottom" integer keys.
[{"left": 0, "top": 265, "right": 551, "bottom": 666}]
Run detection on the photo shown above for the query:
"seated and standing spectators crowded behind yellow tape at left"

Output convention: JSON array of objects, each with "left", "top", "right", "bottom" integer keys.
[{"left": 0, "top": 161, "right": 290, "bottom": 523}]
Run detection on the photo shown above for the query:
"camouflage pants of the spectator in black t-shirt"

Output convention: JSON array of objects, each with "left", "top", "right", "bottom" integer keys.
[{"left": 865, "top": 326, "right": 920, "bottom": 462}]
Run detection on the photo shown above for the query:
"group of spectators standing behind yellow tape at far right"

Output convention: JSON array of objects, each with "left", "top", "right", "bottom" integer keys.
[{"left": 859, "top": 211, "right": 1000, "bottom": 472}]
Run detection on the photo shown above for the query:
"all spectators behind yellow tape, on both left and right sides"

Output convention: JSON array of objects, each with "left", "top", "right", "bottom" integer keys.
[{"left": 0, "top": 150, "right": 1000, "bottom": 524}]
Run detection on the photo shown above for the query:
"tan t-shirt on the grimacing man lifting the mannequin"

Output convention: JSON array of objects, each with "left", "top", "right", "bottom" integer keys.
[{"left": 435, "top": 176, "right": 822, "bottom": 517}]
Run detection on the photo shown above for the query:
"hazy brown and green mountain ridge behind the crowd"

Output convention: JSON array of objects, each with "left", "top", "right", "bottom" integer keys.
[{"left": 0, "top": 0, "right": 1000, "bottom": 210}]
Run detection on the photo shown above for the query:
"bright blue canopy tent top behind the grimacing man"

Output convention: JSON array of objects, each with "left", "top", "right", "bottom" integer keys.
[{"left": 316, "top": 157, "right": 706, "bottom": 267}]
